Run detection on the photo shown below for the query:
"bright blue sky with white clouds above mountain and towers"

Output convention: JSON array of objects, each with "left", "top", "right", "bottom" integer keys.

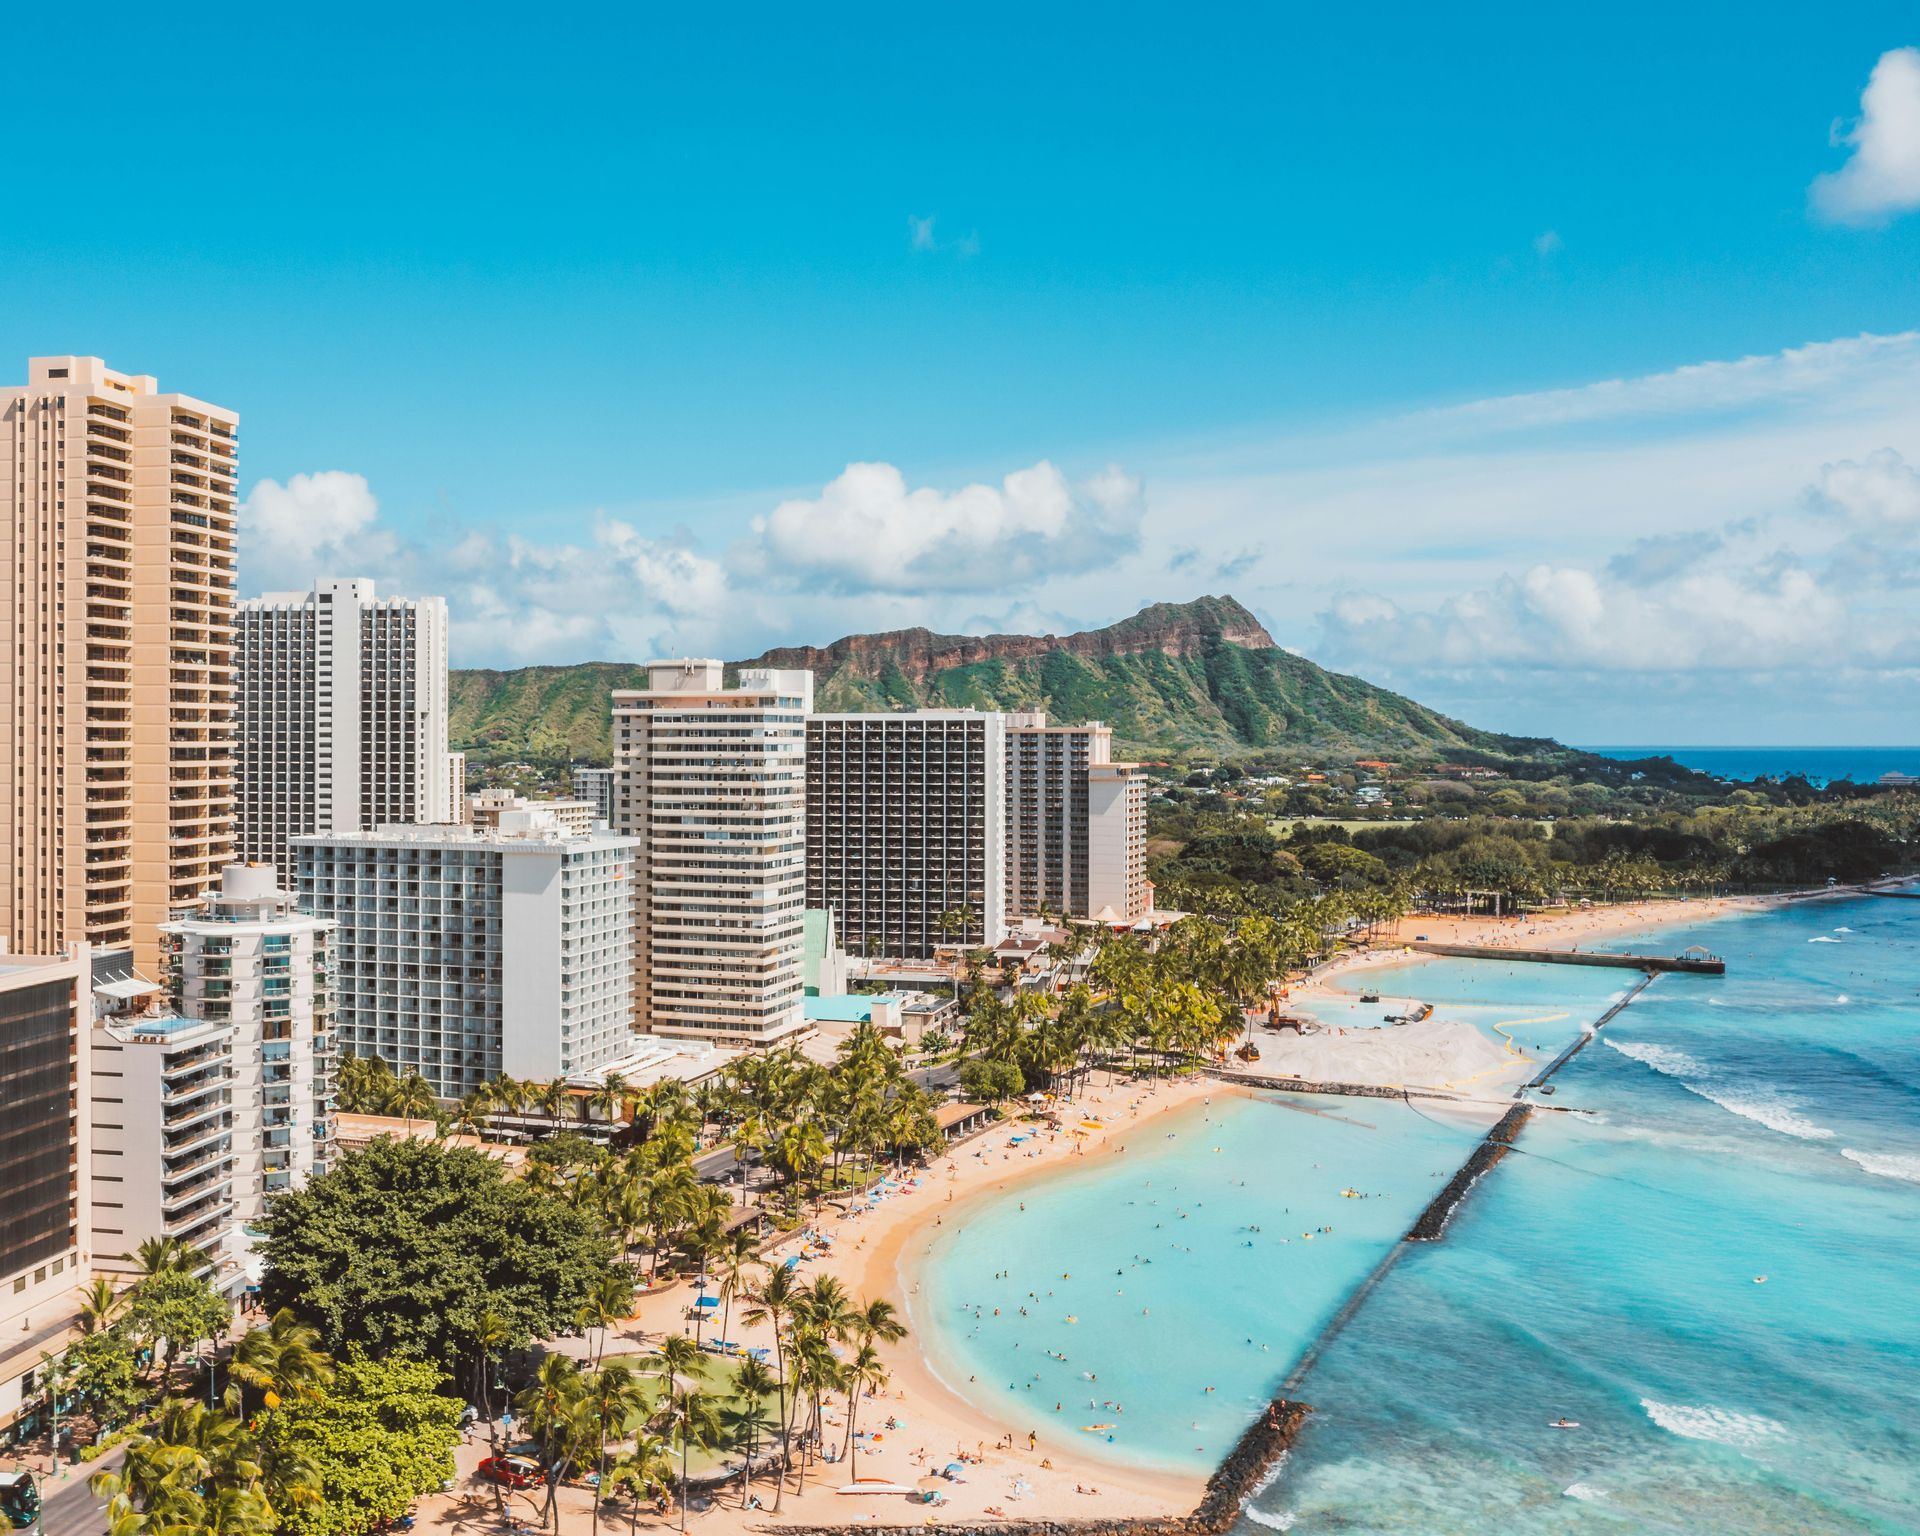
[{"left": 0, "top": 4, "right": 1920, "bottom": 741}]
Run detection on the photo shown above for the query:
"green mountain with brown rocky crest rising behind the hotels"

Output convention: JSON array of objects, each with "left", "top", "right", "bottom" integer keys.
[{"left": 449, "top": 597, "right": 1567, "bottom": 762}]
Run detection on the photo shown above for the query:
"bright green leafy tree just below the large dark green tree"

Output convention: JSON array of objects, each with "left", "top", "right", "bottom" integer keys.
[{"left": 267, "top": 1359, "right": 461, "bottom": 1536}]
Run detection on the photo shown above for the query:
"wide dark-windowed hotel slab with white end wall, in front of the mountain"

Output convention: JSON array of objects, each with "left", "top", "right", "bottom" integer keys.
[{"left": 806, "top": 710, "right": 1008, "bottom": 958}]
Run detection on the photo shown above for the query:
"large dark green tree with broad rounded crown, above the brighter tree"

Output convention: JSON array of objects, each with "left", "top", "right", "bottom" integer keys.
[{"left": 259, "top": 1137, "right": 614, "bottom": 1375}]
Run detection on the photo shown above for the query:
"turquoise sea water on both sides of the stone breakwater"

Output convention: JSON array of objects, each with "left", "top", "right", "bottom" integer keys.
[{"left": 912, "top": 899, "right": 1920, "bottom": 1536}]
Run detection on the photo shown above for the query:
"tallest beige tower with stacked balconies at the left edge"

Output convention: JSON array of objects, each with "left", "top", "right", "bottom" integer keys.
[{"left": 0, "top": 357, "right": 240, "bottom": 972}]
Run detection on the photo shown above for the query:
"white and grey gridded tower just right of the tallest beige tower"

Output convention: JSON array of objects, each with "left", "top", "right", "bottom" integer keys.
[{"left": 236, "top": 580, "right": 461, "bottom": 883}]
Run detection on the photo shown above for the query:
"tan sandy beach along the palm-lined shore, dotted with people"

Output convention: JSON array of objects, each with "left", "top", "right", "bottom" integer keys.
[{"left": 420, "top": 893, "right": 1804, "bottom": 1532}]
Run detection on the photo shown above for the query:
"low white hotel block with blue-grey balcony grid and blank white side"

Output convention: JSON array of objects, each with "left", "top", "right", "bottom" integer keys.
[{"left": 294, "top": 808, "right": 636, "bottom": 1098}]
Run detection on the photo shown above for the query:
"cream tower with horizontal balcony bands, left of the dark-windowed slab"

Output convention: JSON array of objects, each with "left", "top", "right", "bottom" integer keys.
[{"left": 612, "top": 660, "right": 814, "bottom": 1044}]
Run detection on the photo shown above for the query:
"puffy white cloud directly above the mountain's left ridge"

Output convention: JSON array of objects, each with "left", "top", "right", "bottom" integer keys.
[{"left": 753, "top": 459, "right": 1142, "bottom": 593}]
